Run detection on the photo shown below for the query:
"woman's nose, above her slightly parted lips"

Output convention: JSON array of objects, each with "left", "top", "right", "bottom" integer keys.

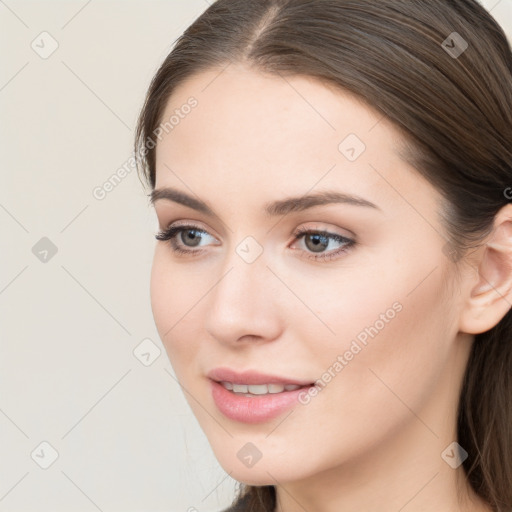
[{"left": 205, "top": 249, "right": 284, "bottom": 347}]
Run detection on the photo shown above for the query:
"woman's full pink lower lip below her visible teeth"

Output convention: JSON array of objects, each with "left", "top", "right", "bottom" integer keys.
[{"left": 211, "top": 380, "right": 308, "bottom": 423}]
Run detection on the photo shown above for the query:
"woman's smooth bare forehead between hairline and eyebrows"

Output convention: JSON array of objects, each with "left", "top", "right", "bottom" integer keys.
[{"left": 156, "top": 64, "right": 440, "bottom": 219}]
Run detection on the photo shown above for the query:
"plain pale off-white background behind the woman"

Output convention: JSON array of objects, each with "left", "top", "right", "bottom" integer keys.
[{"left": 0, "top": 0, "right": 512, "bottom": 512}]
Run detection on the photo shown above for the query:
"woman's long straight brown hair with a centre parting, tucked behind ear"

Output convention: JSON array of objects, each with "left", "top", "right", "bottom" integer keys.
[{"left": 135, "top": 0, "right": 512, "bottom": 512}]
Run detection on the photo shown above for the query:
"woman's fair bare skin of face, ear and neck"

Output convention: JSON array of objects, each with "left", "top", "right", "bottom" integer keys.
[{"left": 147, "top": 65, "right": 512, "bottom": 512}]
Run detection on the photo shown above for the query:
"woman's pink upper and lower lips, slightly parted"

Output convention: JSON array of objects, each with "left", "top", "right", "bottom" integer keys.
[{"left": 208, "top": 368, "right": 312, "bottom": 423}]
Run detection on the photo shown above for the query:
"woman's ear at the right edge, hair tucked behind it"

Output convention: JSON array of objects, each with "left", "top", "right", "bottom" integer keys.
[{"left": 459, "top": 204, "right": 512, "bottom": 334}]
